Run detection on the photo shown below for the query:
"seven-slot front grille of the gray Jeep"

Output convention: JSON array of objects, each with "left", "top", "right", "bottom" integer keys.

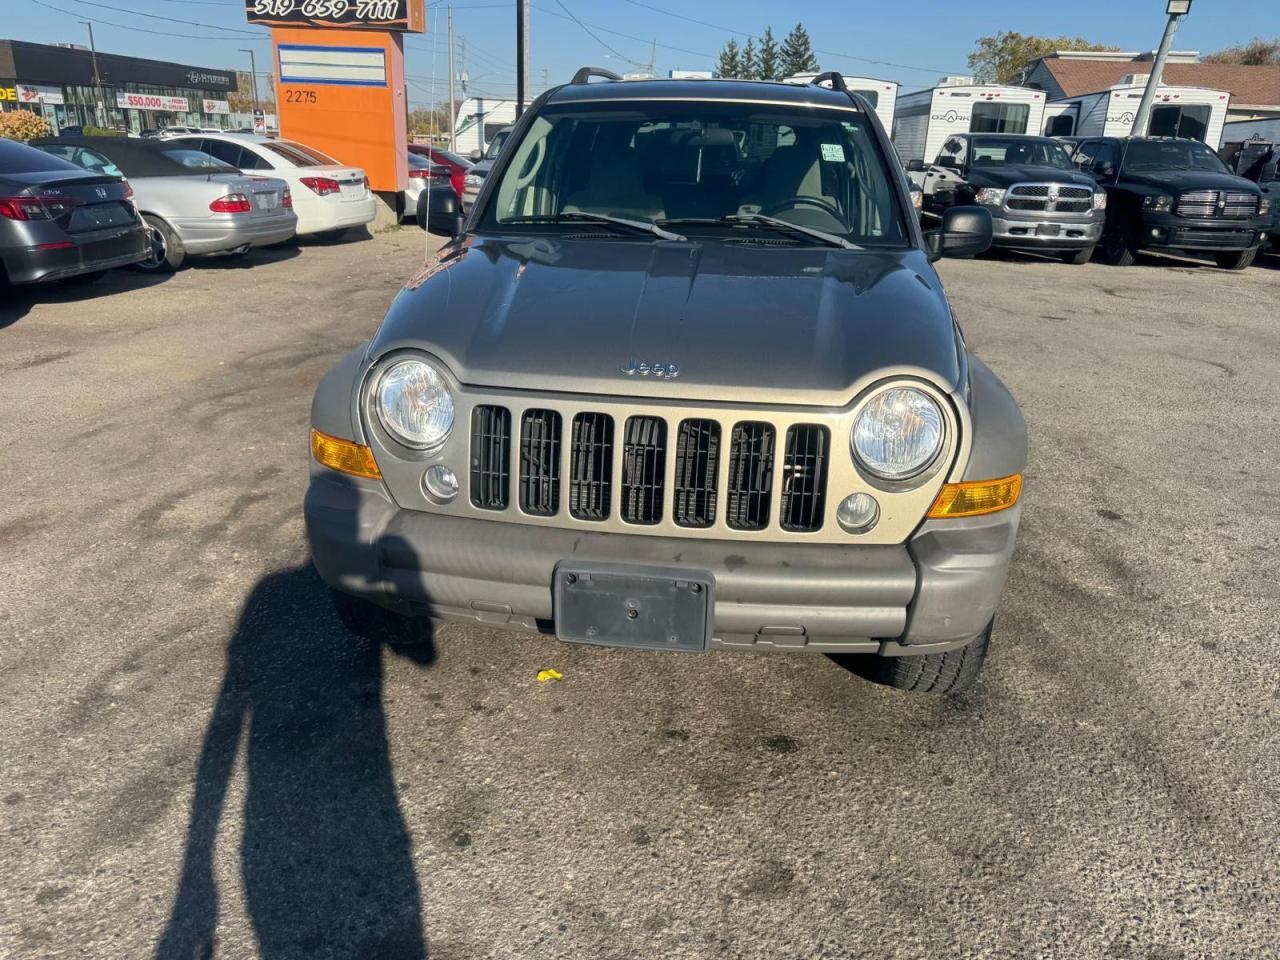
[{"left": 468, "top": 404, "right": 831, "bottom": 532}]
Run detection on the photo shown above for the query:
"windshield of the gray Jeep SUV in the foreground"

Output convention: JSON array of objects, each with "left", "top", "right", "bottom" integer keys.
[{"left": 485, "top": 101, "right": 906, "bottom": 244}]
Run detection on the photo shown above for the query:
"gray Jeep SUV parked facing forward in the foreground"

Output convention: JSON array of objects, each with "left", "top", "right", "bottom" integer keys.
[{"left": 306, "top": 68, "right": 1027, "bottom": 692}]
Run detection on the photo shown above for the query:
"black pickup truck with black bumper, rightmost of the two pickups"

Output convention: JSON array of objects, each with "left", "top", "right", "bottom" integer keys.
[{"left": 1071, "top": 137, "right": 1271, "bottom": 270}]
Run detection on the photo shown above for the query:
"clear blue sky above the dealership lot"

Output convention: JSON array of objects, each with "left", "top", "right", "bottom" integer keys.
[{"left": 0, "top": 0, "right": 1280, "bottom": 105}]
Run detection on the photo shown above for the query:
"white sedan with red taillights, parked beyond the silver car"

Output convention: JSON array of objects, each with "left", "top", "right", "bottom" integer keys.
[{"left": 167, "top": 133, "right": 376, "bottom": 237}]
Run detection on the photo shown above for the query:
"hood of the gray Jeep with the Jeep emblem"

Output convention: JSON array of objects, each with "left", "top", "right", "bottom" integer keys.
[{"left": 369, "top": 240, "right": 961, "bottom": 406}]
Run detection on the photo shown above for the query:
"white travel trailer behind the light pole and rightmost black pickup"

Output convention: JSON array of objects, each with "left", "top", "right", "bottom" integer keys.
[{"left": 1043, "top": 74, "right": 1231, "bottom": 150}]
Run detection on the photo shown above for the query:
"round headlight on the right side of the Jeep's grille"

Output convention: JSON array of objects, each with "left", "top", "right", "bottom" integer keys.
[{"left": 850, "top": 387, "right": 946, "bottom": 480}]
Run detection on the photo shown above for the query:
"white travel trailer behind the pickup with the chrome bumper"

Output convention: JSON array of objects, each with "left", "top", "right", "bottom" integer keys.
[{"left": 893, "top": 77, "right": 1044, "bottom": 163}]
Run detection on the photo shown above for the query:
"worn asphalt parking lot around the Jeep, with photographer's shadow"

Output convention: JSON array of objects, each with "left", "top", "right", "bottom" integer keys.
[{"left": 0, "top": 229, "right": 1280, "bottom": 960}]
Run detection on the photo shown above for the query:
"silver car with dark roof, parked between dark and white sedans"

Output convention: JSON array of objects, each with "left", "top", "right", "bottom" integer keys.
[{"left": 32, "top": 137, "right": 298, "bottom": 271}]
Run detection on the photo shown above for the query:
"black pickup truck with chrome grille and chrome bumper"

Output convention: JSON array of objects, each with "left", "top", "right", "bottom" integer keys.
[{"left": 908, "top": 133, "right": 1106, "bottom": 264}]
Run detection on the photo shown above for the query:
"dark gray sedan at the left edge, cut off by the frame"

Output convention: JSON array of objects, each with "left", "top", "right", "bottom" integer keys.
[{"left": 0, "top": 137, "right": 150, "bottom": 283}]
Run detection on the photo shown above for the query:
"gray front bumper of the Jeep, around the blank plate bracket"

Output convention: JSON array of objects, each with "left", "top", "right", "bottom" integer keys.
[{"left": 305, "top": 465, "right": 1020, "bottom": 655}]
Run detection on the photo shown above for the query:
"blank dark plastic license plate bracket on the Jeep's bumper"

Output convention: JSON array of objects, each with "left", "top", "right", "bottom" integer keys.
[{"left": 553, "top": 561, "right": 716, "bottom": 653}]
